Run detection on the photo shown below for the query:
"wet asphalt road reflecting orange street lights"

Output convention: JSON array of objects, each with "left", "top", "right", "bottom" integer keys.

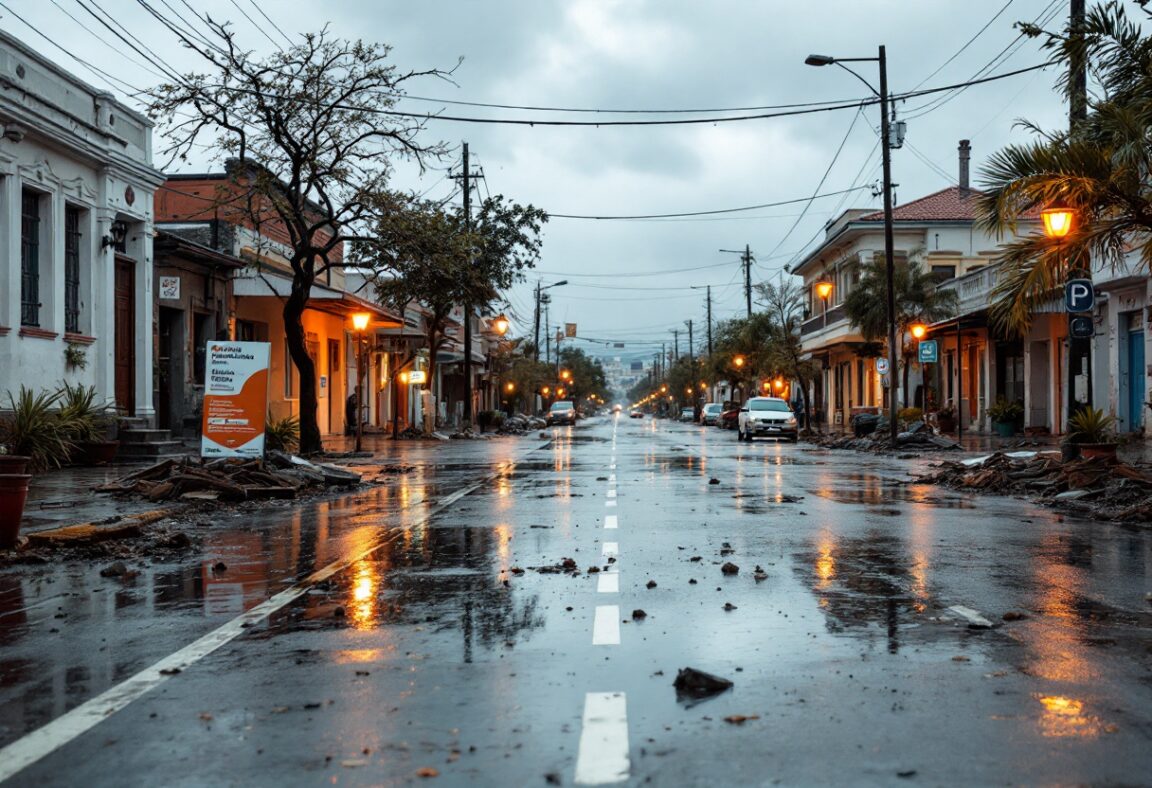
[{"left": 0, "top": 418, "right": 1152, "bottom": 786}]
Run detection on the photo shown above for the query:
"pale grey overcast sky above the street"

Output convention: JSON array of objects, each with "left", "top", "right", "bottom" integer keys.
[{"left": 0, "top": 0, "right": 1069, "bottom": 358}]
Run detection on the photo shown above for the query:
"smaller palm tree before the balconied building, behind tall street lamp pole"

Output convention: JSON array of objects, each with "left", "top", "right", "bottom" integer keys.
[{"left": 844, "top": 255, "right": 958, "bottom": 402}]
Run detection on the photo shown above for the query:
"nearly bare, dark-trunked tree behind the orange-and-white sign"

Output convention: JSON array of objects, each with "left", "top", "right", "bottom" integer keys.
[{"left": 149, "top": 18, "right": 448, "bottom": 454}]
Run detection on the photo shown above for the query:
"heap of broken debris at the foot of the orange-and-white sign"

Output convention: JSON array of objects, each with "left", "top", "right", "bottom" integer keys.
[{"left": 96, "top": 452, "right": 361, "bottom": 501}]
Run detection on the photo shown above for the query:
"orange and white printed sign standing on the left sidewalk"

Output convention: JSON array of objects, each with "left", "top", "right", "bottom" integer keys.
[{"left": 200, "top": 340, "right": 272, "bottom": 457}]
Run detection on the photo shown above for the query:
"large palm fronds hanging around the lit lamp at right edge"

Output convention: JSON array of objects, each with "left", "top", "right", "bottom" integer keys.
[{"left": 977, "top": 0, "right": 1152, "bottom": 336}]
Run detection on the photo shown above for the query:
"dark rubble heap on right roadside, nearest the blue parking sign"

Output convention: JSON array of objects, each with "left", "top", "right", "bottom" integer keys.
[{"left": 915, "top": 452, "right": 1152, "bottom": 522}]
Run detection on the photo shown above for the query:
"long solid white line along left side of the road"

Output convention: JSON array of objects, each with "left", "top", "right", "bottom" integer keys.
[{"left": 0, "top": 449, "right": 529, "bottom": 782}]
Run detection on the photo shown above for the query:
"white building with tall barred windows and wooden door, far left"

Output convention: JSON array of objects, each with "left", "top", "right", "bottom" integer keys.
[{"left": 0, "top": 32, "right": 164, "bottom": 420}]
